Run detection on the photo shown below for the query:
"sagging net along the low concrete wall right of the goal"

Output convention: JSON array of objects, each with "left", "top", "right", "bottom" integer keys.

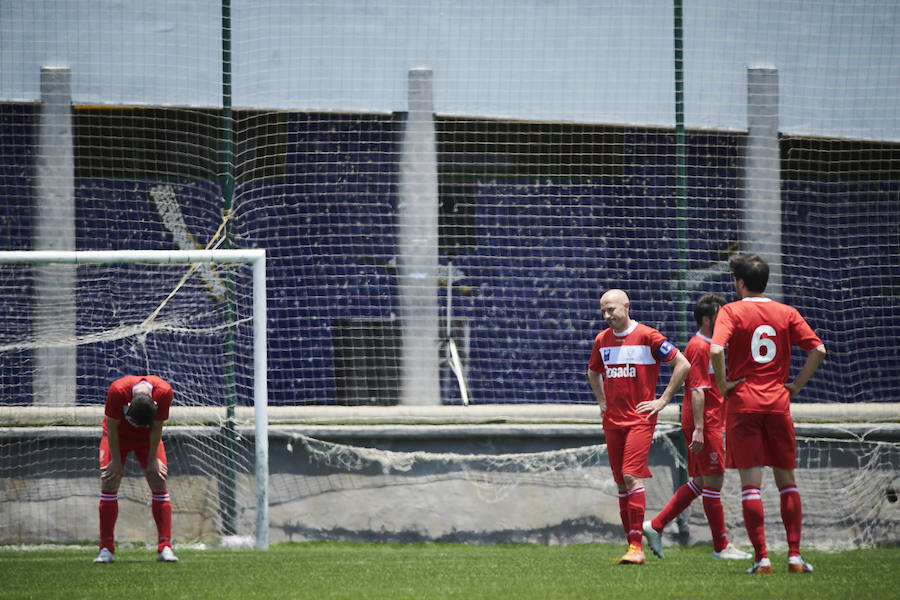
[{"left": 256, "top": 423, "right": 900, "bottom": 551}]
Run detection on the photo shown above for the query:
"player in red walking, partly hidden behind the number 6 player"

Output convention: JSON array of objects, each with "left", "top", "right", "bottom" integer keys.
[{"left": 644, "top": 294, "right": 750, "bottom": 559}]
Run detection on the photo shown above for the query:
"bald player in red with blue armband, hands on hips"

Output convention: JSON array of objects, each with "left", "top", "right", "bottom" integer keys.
[{"left": 588, "top": 289, "right": 690, "bottom": 564}]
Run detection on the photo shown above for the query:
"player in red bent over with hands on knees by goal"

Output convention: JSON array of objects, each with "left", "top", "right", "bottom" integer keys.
[{"left": 94, "top": 375, "right": 178, "bottom": 563}]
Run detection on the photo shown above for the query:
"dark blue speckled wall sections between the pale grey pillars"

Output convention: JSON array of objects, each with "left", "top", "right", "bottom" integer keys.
[{"left": 0, "top": 105, "right": 900, "bottom": 405}]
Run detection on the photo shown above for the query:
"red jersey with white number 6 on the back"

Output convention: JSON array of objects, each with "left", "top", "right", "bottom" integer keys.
[{"left": 712, "top": 297, "right": 822, "bottom": 414}]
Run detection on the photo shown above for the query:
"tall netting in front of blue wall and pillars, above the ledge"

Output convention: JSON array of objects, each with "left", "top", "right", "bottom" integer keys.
[{"left": 0, "top": 0, "right": 900, "bottom": 406}]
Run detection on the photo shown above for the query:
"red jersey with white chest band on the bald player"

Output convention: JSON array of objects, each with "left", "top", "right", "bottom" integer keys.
[{"left": 588, "top": 321, "right": 678, "bottom": 427}]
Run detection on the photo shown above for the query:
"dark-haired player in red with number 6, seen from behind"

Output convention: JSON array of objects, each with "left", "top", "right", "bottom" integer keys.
[{"left": 710, "top": 254, "right": 825, "bottom": 573}]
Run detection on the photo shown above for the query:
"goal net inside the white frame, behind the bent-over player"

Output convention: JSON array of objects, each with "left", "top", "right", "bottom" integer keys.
[{"left": 0, "top": 250, "right": 268, "bottom": 547}]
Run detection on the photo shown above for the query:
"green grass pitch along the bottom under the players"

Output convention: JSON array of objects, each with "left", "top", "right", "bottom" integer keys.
[{"left": 0, "top": 542, "right": 900, "bottom": 600}]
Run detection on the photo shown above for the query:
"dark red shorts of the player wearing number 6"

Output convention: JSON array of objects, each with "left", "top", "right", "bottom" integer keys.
[{"left": 725, "top": 413, "right": 797, "bottom": 469}]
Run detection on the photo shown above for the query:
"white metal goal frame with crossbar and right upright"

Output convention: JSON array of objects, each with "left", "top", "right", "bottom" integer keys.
[{"left": 0, "top": 249, "right": 269, "bottom": 549}]
